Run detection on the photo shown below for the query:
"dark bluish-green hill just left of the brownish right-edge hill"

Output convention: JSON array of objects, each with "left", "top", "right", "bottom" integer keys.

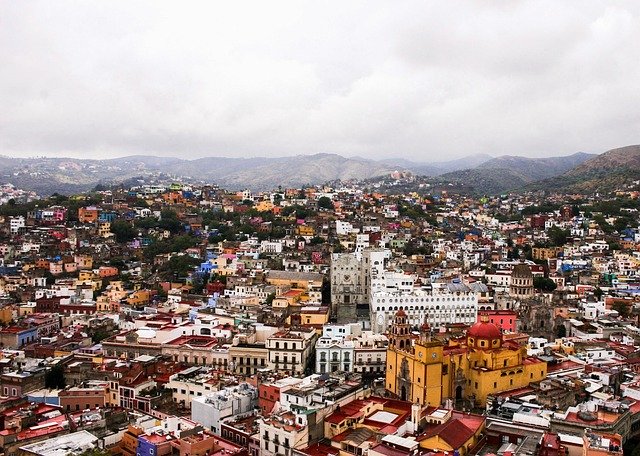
[{"left": 435, "top": 152, "right": 595, "bottom": 194}]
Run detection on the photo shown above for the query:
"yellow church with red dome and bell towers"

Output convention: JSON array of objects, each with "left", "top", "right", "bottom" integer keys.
[{"left": 386, "top": 309, "right": 547, "bottom": 407}]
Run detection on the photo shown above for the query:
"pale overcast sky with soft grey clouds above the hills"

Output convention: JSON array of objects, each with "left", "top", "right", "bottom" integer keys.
[{"left": 0, "top": 0, "right": 640, "bottom": 162}]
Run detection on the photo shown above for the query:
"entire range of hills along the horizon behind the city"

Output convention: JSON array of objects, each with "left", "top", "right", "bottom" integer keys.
[{"left": 0, "top": 146, "right": 640, "bottom": 196}]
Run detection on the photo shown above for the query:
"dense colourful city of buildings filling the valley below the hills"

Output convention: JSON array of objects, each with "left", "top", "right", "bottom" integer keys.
[{"left": 0, "top": 180, "right": 640, "bottom": 456}]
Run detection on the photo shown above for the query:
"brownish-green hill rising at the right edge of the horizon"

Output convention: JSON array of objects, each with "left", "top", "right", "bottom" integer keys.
[{"left": 531, "top": 145, "right": 640, "bottom": 193}]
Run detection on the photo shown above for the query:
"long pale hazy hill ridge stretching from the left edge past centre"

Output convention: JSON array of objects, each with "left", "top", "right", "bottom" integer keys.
[{"left": 0, "top": 154, "right": 397, "bottom": 196}]
